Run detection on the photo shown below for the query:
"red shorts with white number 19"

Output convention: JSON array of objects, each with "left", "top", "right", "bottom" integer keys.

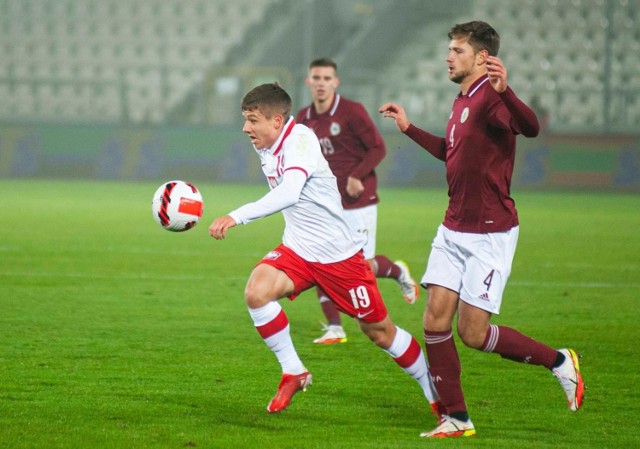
[{"left": 259, "top": 245, "right": 387, "bottom": 323}]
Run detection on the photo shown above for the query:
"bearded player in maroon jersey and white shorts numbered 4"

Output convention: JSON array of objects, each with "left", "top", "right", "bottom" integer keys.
[{"left": 380, "top": 21, "right": 584, "bottom": 438}]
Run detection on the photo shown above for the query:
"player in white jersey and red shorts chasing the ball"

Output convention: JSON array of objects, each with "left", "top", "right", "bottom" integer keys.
[{"left": 209, "top": 83, "right": 439, "bottom": 422}]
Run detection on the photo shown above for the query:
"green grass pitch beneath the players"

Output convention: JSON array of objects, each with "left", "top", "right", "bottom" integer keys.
[{"left": 0, "top": 179, "right": 640, "bottom": 449}]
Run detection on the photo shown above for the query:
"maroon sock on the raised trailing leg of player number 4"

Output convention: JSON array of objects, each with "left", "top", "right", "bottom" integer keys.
[{"left": 482, "top": 324, "right": 558, "bottom": 369}]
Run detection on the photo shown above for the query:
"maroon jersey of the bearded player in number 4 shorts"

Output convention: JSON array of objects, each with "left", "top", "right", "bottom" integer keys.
[{"left": 406, "top": 75, "right": 539, "bottom": 233}]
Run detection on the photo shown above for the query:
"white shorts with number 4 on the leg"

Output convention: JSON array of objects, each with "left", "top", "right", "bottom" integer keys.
[{"left": 421, "top": 225, "right": 520, "bottom": 314}]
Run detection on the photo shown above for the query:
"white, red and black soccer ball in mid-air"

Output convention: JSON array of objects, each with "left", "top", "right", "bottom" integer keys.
[{"left": 151, "top": 180, "right": 204, "bottom": 232}]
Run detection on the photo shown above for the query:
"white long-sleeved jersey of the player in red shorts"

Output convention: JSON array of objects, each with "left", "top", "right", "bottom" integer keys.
[{"left": 229, "top": 117, "right": 364, "bottom": 263}]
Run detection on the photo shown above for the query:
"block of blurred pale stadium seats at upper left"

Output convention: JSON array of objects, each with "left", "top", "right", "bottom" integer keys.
[{"left": 0, "top": 0, "right": 274, "bottom": 123}]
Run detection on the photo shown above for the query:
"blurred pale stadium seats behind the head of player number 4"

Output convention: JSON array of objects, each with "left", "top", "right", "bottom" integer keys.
[{"left": 382, "top": 0, "right": 640, "bottom": 132}]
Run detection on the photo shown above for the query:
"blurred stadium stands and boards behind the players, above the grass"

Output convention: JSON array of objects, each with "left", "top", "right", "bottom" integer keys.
[{"left": 0, "top": 0, "right": 640, "bottom": 192}]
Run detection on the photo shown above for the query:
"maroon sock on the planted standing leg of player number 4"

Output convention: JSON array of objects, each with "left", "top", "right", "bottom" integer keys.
[{"left": 424, "top": 329, "right": 467, "bottom": 414}]
